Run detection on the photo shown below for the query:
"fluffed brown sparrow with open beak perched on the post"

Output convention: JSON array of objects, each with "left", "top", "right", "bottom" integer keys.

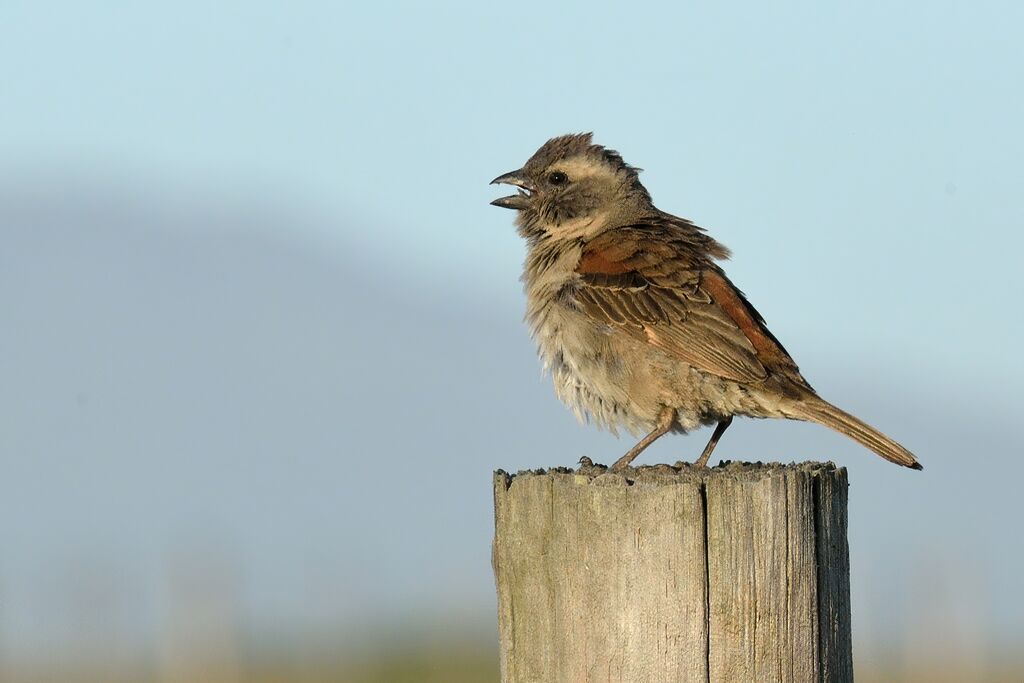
[{"left": 490, "top": 133, "right": 923, "bottom": 470}]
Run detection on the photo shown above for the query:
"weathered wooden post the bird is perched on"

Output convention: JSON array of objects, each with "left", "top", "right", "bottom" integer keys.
[{"left": 493, "top": 463, "right": 853, "bottom": 683}]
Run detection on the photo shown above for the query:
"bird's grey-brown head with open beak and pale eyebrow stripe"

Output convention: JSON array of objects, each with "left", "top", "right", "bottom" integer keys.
[{"left": 490, "top": 133, "right": 650, "bottom": 237}]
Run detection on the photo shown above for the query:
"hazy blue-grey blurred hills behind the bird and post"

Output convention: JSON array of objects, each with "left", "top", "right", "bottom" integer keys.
[{"left": 0, "top": 184, "right": 1024, "bottom": 680}]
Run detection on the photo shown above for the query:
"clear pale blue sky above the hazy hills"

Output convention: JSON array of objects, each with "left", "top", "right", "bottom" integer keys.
[{"left": 0, "top": 1, "right": 1024, "bottom": 377}]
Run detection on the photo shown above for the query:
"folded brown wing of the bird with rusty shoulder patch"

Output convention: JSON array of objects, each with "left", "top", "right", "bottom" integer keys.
[{"left": 574, "top": 223, "right": 805, "bottom": 384}]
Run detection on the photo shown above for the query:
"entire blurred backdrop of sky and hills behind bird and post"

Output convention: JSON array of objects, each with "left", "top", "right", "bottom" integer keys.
[{"left": 0, "top": 0, "right": 1024, "bottom": 683}]
